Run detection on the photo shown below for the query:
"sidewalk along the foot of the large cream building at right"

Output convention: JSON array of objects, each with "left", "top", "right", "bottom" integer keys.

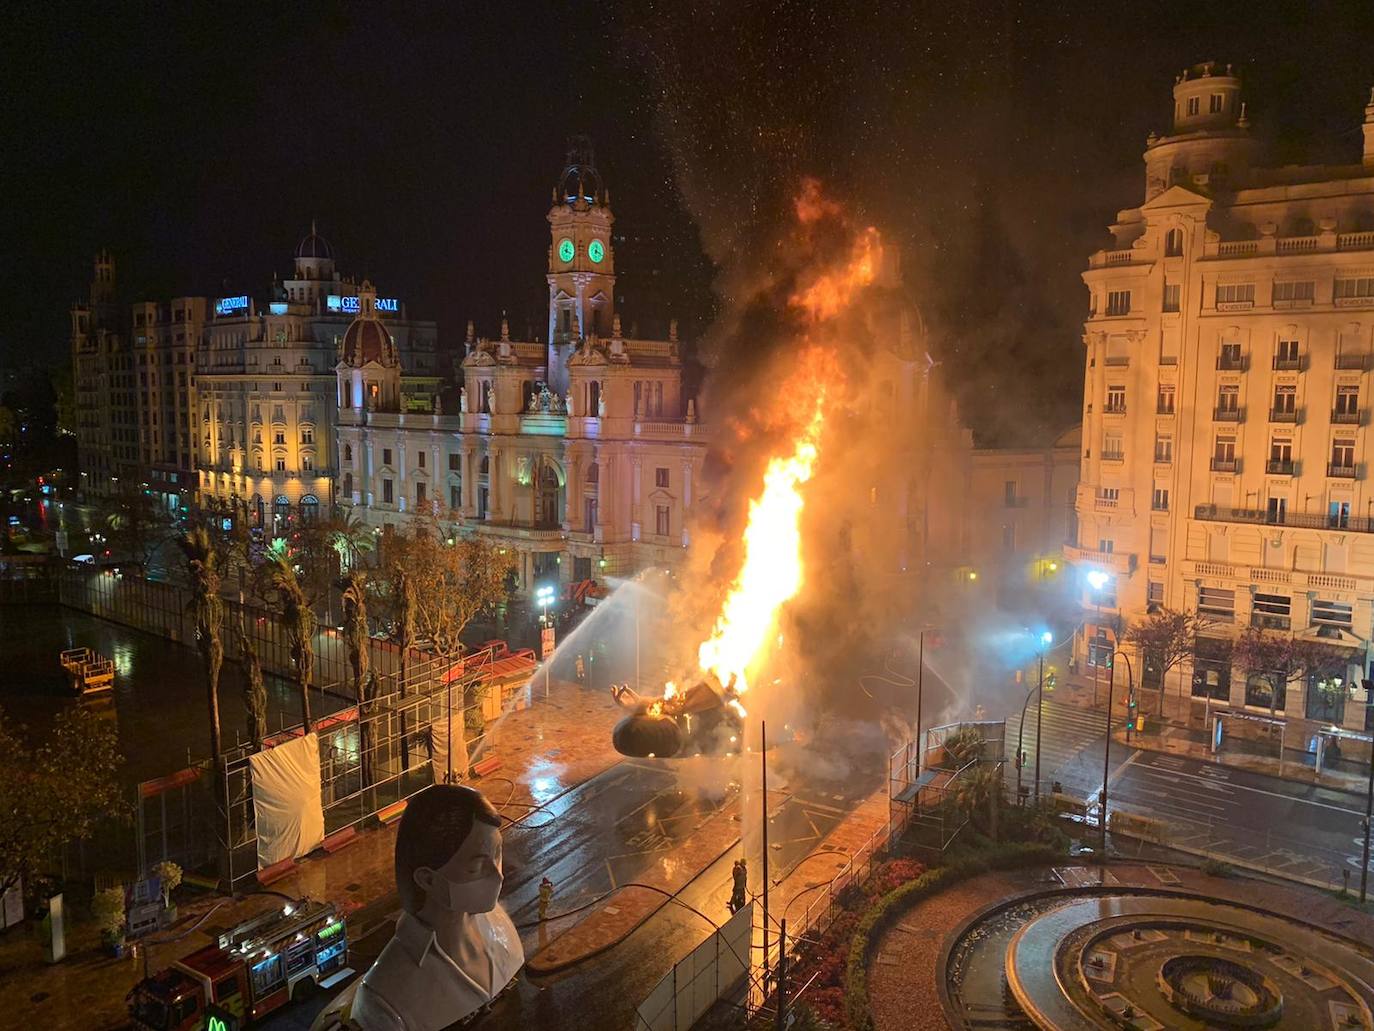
[{"left": 1052, "top": 675, "right": 1367, "bottom": 799}]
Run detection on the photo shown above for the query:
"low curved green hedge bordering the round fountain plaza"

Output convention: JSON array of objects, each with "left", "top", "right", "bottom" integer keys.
[{"left": 845, "top": 843, "right": 1065, "bottom": 1031}]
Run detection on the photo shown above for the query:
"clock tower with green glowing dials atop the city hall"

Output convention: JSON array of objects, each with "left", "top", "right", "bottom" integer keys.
[{"left": 548, "top": 136, "right": 616, "bottom": 392}]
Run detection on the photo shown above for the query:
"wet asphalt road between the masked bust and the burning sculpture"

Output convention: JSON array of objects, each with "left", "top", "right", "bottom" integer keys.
[{"left": 264, "top": 742, "right": 882, "bottom": 1031}]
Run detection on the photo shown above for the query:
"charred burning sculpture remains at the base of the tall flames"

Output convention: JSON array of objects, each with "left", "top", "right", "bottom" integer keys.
[{"left": 611, "top": 674, "right": 746, "bottom": 759}]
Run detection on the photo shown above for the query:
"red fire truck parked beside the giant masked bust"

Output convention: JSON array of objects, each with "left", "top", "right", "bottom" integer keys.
[{"left": 126, "top": 899, "right": 348, "bottom": 1031}]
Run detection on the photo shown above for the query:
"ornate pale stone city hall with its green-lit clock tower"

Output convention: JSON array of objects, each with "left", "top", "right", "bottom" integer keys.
[{"left": 335, "top": 147, "right": 708, "bottom": 587}]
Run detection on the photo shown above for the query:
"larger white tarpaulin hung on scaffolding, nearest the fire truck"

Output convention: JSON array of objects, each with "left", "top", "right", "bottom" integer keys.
[{"left": 249, "top": 734, "right": 324, "bottom": 870}]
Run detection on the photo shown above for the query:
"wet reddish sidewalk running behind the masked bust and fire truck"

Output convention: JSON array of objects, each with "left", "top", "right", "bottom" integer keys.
[{"left": 0, "top": 680, "right": 621, "bottom": 1031}]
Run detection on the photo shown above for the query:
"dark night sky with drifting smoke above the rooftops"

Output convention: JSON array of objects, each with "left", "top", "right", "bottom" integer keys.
[{"left": 8, "top": 0, "right": 1374, "bottom": 440}]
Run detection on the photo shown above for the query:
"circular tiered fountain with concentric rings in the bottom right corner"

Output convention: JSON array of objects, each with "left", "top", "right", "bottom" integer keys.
[{"left": 943, "top": 887, "right": 1374, "bottom": 1031}]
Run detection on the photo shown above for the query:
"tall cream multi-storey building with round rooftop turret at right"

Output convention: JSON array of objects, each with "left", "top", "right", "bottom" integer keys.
[{"left": 1066, "top": 63, "right": 1374, "bottom": 741}]
